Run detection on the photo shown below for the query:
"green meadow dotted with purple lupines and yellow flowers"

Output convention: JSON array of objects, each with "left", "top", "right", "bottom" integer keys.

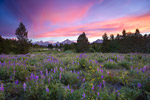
[{"left": 0, "top": 51, "right": 150, "bottom": 100}]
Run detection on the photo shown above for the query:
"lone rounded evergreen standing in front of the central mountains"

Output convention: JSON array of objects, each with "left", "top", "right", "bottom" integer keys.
[{"left": 76, "top": 32, "right": 89, "bottom": 52}]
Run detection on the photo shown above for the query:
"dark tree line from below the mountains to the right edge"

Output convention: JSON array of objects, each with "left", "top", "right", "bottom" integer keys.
[{"left": 48, "top": 29, "right": 150, "bottom": 53}]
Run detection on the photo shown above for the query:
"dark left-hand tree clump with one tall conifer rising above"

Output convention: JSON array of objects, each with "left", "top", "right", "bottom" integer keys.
[{"left": 0, "top": 23, "right": 32, "bottom": 54}]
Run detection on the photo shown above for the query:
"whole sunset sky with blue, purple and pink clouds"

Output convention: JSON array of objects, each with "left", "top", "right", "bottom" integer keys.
[{"left": 0, "top": 0, "right": 150, "bottom": 42}]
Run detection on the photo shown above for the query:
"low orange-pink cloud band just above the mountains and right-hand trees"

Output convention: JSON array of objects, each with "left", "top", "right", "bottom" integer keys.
[{"left": 36, "top": 14, "right": 150, "bottom": 38}]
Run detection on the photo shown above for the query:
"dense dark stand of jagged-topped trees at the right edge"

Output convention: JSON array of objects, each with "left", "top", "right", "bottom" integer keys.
[{"left": 101, "top": 29, "right": 150, "bottom": 53}]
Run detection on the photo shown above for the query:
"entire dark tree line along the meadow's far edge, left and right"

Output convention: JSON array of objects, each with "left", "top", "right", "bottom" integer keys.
[{"left": 0, "top": 23, "right": 150, "bottom": 54}]
